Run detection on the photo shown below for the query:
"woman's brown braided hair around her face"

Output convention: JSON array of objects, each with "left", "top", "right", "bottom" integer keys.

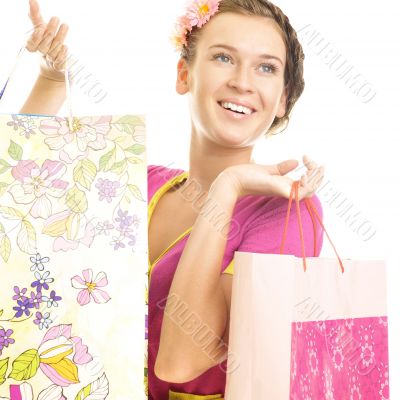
[{"left": 181, "top": 0, "right": 304, "bottom": 135}]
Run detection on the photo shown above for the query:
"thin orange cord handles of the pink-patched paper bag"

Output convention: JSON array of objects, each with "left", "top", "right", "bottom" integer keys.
[{"left": 280, "top": 181, "right": 344, "bottom": 273}]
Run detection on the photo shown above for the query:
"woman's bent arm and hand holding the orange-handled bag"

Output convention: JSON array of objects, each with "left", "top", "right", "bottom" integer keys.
[{"left": 155, "top": 155, "right": 323, "bottom": 383}]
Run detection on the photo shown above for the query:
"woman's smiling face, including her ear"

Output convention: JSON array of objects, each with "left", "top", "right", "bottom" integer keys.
[{"left": 177, "top": 13, "right": 286, "bottom": 148}]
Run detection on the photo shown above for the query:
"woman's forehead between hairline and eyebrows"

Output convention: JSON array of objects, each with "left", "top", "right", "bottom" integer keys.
[{"left": 198, "top": 13, "right": 286, "bottom": 63}]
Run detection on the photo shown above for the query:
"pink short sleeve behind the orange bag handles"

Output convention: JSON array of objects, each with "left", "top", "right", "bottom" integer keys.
[{"left": 223, "top": 195, "right": 323, "bottom": 275}]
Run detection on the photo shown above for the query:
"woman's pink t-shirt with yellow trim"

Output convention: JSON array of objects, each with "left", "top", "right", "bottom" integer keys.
[{"left": 148, "top": 165, "right": 323, "bottom": 400}]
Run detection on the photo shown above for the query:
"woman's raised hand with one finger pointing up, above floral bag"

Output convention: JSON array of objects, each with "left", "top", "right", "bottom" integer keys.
[{"left": 26, "top": 0, "right": 68, "bottom": 81}]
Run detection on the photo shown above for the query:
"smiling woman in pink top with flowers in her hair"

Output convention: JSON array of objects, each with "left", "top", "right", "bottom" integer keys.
[{"left": 23, "top": 0, "right": 324, "bottom": 400}]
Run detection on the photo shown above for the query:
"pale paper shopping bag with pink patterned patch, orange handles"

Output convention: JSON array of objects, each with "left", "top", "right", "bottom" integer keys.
[{"left": 225, "top": 182, "right": 389, "bottom": 400}]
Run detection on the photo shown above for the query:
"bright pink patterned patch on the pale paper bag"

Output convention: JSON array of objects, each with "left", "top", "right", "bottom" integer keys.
[{"left": 290, "top": 317, "right": 389, "bottom": 400}]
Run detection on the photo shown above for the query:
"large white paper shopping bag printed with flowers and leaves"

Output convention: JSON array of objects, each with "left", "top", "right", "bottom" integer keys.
[{"left": 0, "top": 115, "right": 147, "bottom": 400}]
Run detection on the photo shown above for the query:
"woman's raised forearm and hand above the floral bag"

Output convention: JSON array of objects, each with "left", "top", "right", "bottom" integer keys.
[{"left": 20, "top": 0, "right": 68, "bottom": 114}]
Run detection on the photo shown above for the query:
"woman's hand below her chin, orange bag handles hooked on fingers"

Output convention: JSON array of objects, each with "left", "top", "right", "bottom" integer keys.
[{"left": 219, "top": 156, "right": 324, "bottom": 200}]
